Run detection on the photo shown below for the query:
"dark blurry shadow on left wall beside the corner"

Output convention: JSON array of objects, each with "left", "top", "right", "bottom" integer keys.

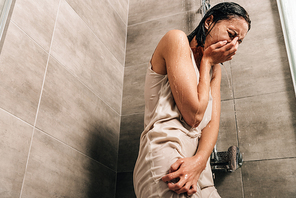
[{"left": 86, "top": 122, "right": 118, "bottom": 198}]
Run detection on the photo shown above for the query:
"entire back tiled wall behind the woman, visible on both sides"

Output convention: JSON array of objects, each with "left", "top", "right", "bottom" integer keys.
[{"left": 116, "top": 0, "right": 296, "bottom": 198}]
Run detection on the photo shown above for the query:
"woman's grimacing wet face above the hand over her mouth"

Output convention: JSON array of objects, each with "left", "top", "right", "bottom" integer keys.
[{"left": 204, "top": 16, "right": 248, "bottom": 48}]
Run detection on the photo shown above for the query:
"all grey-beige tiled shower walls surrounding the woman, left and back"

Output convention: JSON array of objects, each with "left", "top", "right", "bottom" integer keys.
[{"left": 0, "top": 0, "right": 296, "bottom": 198}]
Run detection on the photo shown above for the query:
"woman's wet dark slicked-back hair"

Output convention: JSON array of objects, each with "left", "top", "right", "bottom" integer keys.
[{"left": 187, "top": 2, "right": 251, "bottom": 47}]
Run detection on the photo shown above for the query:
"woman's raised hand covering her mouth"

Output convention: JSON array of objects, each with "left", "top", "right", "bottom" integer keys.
[{"left": 202, "top": 37, "right": 238, "bottom": 66}]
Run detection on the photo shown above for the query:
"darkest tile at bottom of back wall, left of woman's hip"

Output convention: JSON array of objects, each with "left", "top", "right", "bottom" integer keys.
[{"left": 115, "top": 172, "right": 136, "bottom": 198}]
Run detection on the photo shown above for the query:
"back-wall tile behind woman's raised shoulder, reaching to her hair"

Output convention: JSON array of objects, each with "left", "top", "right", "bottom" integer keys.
[{"left": 125, "top": 12, "right": 204, "bottom": 67}]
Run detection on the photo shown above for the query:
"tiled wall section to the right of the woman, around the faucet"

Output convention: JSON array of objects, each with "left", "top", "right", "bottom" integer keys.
[{"left": 211, "top": 0, "right": 296, "bottom": 198}]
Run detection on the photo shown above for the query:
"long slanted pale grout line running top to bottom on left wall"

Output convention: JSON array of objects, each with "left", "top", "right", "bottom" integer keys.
[{"left": 20, "top": 0, "right": 61, "bottom": 198}]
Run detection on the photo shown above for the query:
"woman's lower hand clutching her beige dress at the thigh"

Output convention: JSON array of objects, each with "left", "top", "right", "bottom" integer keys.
[{"left": 162, "top": 155, "right": 207, "bottom": 195}]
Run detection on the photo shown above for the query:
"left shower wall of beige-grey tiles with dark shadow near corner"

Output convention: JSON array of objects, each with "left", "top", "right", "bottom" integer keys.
[{"left": 0, "top": 0, "right": 128, "bottom": 198}]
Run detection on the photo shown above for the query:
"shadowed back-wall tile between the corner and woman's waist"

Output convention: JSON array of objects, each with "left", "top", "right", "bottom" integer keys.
[{"left": 117, "top": 113, "right": 144, "bottom": 172}]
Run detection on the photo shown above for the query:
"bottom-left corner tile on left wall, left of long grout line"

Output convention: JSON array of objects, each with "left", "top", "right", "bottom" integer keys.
[{"left": 0, "top": 110, "right": 33, "bottom": 197}]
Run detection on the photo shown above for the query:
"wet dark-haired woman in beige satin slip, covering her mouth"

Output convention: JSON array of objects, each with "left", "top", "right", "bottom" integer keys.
[{"left": 134, "top": 3, "right": 251, "bottom": 198}]
